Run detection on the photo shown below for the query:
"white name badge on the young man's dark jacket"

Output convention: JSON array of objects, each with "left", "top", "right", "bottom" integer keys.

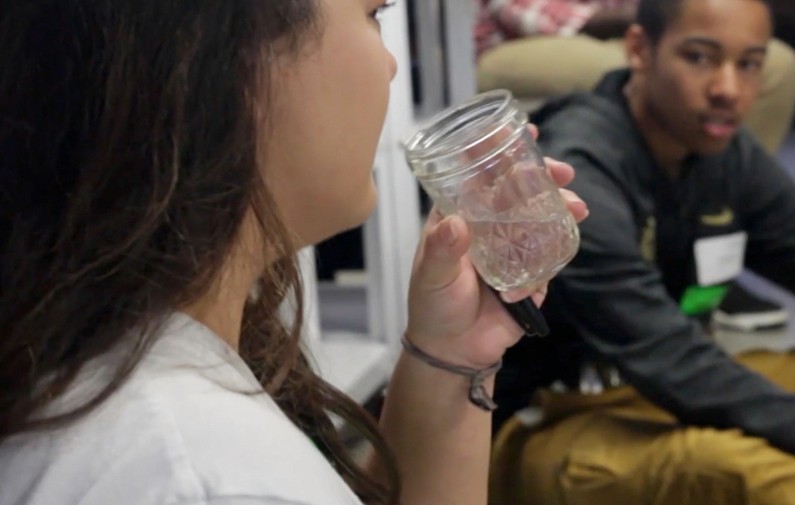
[{"left": 693, "top": 231, "right": 748, "bottom": 286}]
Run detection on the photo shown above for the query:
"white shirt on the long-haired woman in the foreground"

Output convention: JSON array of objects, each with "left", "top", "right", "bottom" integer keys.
[{"left": 0, "top": 314, "right": 361, "bottom": 505}]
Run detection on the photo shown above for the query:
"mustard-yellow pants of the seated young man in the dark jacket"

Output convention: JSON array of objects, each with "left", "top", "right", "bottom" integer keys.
[{"left": 489, "top": 352, "right": 795, "bottom": 505}]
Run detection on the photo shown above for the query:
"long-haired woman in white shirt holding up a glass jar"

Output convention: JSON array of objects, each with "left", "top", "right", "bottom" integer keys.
[{"left": 0, "top": 0, "right": 587, "bottom": 505}]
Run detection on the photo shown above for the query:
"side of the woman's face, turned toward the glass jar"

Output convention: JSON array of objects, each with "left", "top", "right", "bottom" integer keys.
[{"left": 265, "top": 0, "right": 397, "bottom": 245}]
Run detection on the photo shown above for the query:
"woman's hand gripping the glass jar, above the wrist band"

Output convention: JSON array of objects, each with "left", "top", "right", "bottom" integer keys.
[{"left": 406, "top": 150, "right": 588, "bottom": 369}]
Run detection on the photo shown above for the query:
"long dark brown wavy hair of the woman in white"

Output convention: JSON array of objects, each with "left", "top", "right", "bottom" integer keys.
[{"left": 0, "top": 0, "right": 399, "bottom": 503}]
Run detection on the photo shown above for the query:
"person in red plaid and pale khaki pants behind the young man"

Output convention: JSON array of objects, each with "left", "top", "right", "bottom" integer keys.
[{"left": 473, "top": 0, "right": 795, "bottom": 154}]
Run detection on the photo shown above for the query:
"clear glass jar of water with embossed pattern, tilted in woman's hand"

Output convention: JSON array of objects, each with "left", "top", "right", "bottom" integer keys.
[{"left": 406, "top": 90, "right": 580, "bottom": 291}]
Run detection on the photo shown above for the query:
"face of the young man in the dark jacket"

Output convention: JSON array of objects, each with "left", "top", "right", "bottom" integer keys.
[{"left": 642, "top": 0, "right": 772, "bottom": 154}]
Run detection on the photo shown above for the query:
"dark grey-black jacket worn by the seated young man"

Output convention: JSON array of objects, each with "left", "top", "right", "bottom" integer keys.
[{"left": 497, "top": 71, "right": 795, "bottom": 453}]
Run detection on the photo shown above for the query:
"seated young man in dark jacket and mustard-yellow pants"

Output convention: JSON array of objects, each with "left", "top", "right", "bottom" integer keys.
[{"left": 490, "top": 0, "right": 795, "bottom": 505}]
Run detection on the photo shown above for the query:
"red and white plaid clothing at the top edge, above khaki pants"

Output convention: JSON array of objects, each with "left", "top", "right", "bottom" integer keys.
[{"left": 475, "top": 0, "right": 638, "bottom": 54}]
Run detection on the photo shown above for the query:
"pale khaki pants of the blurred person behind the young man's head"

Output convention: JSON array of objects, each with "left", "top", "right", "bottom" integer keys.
[{"left": 477, "top": 36, "right": 795, "bottom": 153}]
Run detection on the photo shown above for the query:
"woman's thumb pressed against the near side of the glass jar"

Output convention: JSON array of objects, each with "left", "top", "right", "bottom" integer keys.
[{"left": 415, "top": 216, "right": 470, "bottom": 291}]
